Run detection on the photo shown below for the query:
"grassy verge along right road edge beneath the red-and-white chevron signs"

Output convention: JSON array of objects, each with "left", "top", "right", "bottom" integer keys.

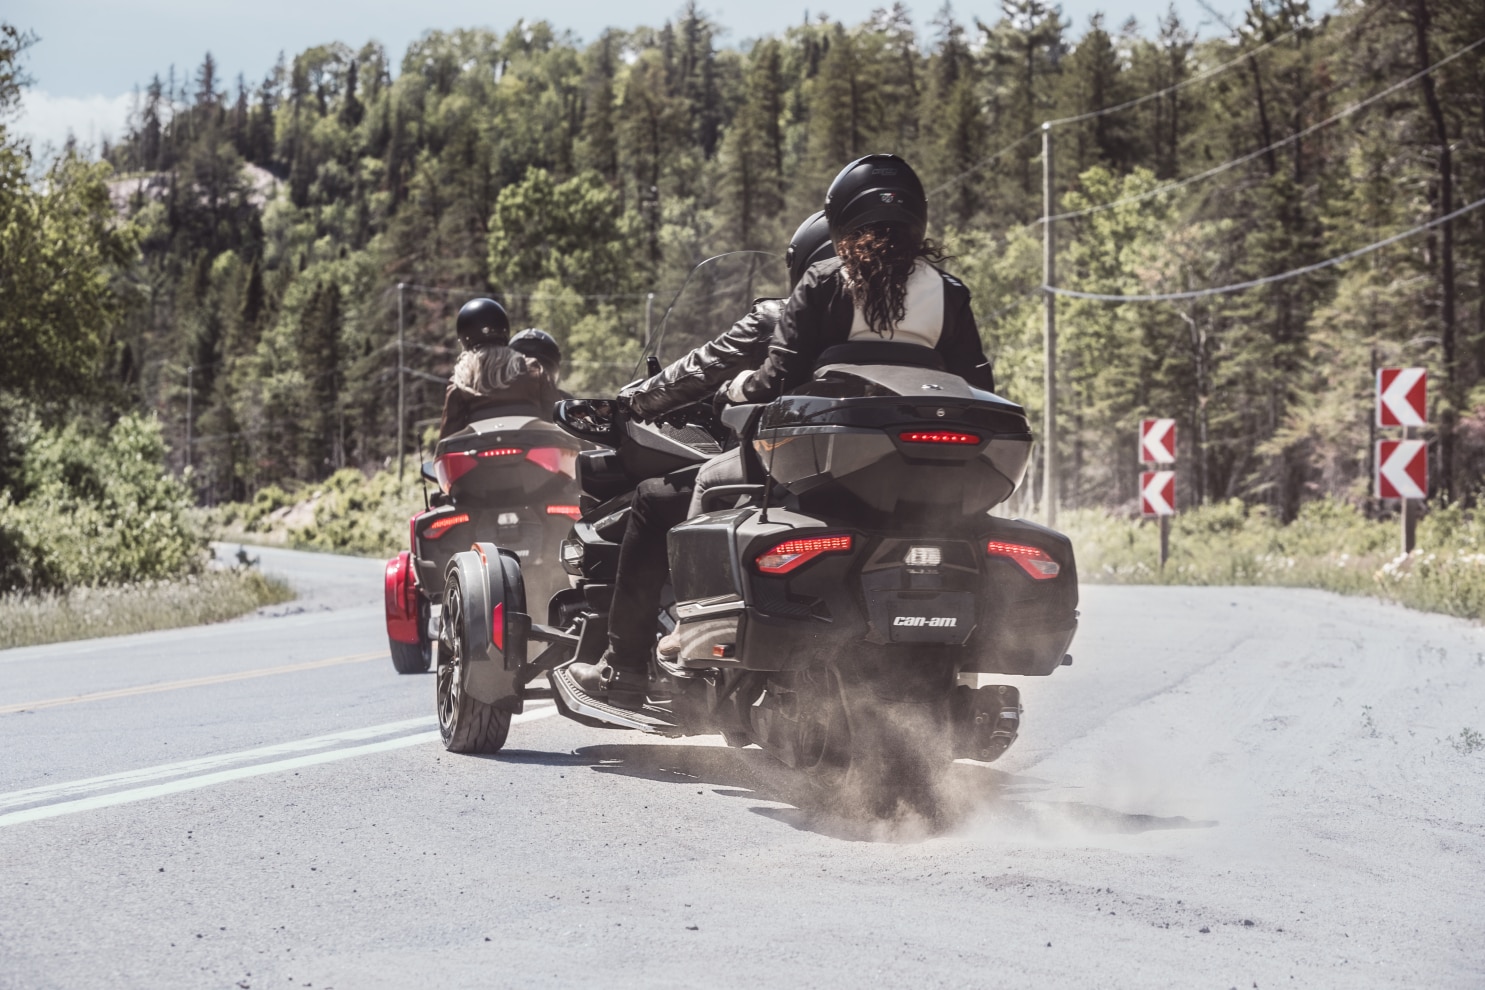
[{"left": 1059, "top": 500, "right": 1485, "bottom": 619}]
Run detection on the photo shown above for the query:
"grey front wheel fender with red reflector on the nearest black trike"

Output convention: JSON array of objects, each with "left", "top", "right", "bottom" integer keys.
[{"left": 446, "top": 543, "right": 532, "bottom": 712}]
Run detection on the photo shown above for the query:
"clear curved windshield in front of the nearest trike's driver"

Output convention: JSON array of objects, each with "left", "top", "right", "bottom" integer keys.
[{"left": 634, "top": 251, "right": 789, "bottom": 378}]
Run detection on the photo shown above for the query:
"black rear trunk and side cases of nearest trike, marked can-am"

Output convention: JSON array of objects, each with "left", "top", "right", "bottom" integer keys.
[{"left": 670, "top": 367, "right": 1077, "bottom": 674}]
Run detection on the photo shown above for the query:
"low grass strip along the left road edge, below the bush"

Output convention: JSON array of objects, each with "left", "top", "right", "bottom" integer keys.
[{"left": 0, "top": 568, "right": 294, "bottom": 649}]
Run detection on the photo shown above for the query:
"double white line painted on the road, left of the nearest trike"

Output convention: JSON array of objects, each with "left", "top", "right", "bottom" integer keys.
[{"left": 0, "top": 705, "right": 557, "bottom": 828}]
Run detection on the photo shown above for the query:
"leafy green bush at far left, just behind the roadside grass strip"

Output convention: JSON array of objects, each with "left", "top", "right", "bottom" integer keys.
[{"left": 0, "top": 414, "right": 206, "bottom": 592}]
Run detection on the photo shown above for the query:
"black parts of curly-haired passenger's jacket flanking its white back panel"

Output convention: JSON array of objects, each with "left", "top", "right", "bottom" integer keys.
[{"left": 743, "top": 258, "right": 995, "bottom": 402}]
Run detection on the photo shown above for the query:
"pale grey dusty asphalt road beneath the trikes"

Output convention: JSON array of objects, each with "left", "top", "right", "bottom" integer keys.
[{"left": 0, "top": 551, "right": 1485, "bottom": 990}]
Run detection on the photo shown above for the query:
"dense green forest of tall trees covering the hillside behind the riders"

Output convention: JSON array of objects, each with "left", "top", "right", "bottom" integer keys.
[{"left": 0, "top": 0, "right": 1485, "bottom": 519}]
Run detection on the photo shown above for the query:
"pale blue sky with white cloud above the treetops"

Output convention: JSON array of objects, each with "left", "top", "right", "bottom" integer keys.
[{"left": 11, "top": 0, "right": 1246, "bottom": 150}]
